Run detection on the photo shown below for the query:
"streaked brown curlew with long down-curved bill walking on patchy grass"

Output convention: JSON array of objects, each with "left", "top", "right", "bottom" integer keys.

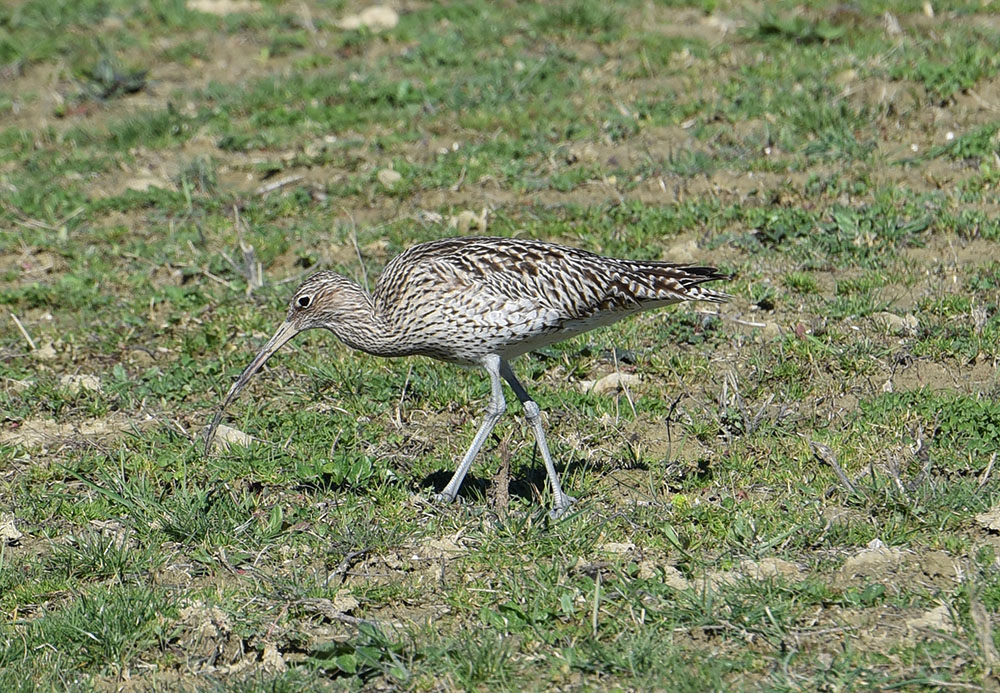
[{"left": 205, "top": 238, "right": 727, "bottom": 517}]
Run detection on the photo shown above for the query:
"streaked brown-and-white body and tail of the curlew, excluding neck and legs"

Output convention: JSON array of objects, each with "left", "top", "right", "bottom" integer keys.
[{"left": 373, "top": 237, "right": 726, "bottom": 364}]
